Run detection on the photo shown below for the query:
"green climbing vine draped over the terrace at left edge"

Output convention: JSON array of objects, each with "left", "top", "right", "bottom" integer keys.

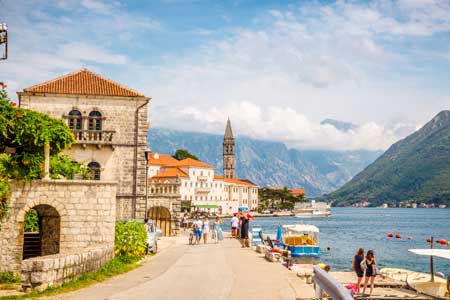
[{"left": 0, "top": 88, "right": 76, "bottom": 221}]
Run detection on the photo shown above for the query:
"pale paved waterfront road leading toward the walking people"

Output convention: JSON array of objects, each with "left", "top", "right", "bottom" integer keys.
[{"left": 47, "top": 234, "right": 312, "bottom": 300}]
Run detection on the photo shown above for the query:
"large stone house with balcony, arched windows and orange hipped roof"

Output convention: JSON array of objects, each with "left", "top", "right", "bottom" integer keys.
[{"left": 17, "top": 69, "right": 150, "bottom": 219}]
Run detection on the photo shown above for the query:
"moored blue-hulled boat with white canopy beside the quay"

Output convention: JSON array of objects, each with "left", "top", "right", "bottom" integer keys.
[{"left": 276, "top": 224, "right": 320, "bottom": 263}]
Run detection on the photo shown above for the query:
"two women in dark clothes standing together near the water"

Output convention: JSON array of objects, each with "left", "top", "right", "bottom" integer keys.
[{"left": 353, "top": 248, "right": 378, "bottom": 295}]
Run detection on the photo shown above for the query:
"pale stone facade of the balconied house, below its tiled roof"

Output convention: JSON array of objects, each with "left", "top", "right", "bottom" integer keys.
[{"left": 20, "top": 93, "right": 148, "bottom": 219}]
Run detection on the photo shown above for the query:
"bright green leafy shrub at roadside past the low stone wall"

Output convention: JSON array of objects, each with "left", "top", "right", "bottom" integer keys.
[{"left": 114, "top": 221, "right": 147, "bottom": 259}]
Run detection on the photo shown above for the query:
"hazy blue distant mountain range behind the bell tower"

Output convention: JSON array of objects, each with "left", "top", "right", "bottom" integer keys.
[{"left": 148, "top": 128, "right": 381, "bottom": 197}]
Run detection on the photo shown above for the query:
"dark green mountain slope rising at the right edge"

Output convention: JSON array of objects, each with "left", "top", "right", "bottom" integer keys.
[{"left": 326, "top": 111, "right": 450, "bottom": 206}]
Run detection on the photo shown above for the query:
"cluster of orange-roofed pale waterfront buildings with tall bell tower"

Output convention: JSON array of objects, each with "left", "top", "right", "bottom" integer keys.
[{"left": 148, "top": 120, "right": 258, "bottom": 215}]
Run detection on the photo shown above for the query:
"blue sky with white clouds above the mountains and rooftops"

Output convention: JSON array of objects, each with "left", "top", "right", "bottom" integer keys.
[{"left": 0, "top": 0, "right": 450, "bottom": 150}]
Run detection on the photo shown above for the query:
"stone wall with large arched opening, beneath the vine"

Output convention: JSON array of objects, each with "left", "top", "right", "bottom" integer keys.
[{"left": 0, "top": 180, "right": 116, "bottom": 273}]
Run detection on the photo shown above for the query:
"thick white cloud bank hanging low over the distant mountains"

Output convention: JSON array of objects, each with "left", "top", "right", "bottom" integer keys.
[{"left": 153, "top": 101, "right": 410, "bottom": 150}]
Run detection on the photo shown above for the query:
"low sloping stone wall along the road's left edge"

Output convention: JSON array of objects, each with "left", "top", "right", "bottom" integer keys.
[{"left": 21, "top": 246, "right": 114, "bottom": 292}]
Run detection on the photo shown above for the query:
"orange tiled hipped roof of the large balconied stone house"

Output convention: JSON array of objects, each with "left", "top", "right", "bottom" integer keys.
[{"left": 23, "top": 69, "right": 145, "bottom": 97}]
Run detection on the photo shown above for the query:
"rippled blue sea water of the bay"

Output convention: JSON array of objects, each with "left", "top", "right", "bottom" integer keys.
[{"left": 239, "top": 208, "right": 450, "bottom": 276}]
